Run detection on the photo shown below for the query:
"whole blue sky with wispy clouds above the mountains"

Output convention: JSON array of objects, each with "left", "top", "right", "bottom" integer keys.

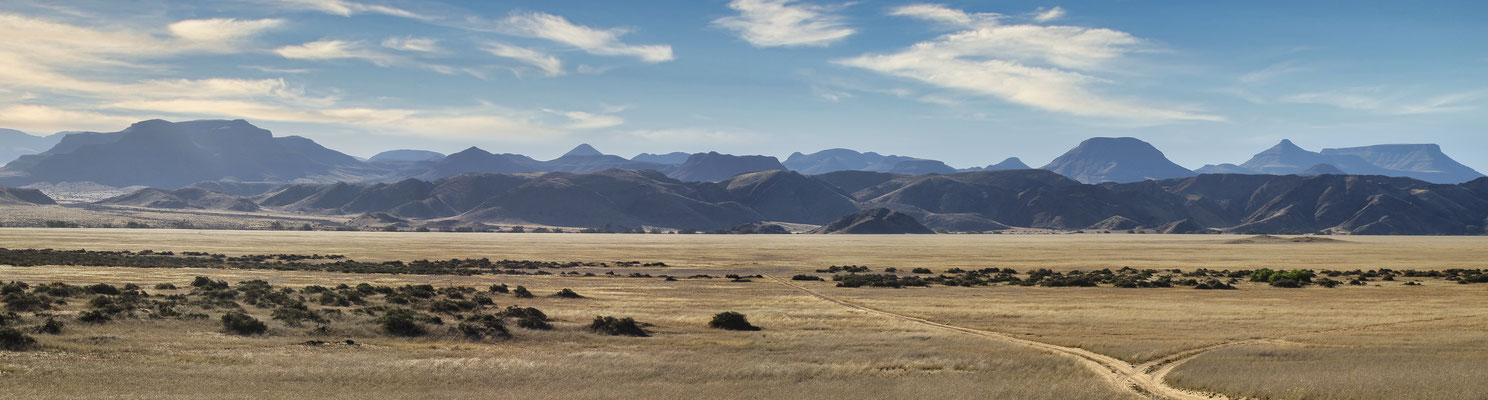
[{"left": 0, "top": 0, "right": 1488, "bottom": 171}]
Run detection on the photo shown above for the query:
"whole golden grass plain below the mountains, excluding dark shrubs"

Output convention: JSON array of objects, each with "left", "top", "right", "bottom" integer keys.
[{"left": 0, "top": 229, "right": 1488, "bottom": 399}]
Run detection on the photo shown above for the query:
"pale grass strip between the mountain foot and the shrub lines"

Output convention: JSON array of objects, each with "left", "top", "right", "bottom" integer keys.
[{"left": 0, "top": 229, "right": 1488, "bottom": 269}]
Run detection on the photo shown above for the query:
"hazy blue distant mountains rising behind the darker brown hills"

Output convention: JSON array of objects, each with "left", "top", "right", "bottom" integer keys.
[{"left": 0, "top": 119, "right": 1482, "bottom": 189}]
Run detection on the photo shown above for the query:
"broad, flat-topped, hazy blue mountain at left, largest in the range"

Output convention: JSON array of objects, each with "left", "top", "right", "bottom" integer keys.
[{"left": 0, "top": 119, "right": 372, "bottom": 187}]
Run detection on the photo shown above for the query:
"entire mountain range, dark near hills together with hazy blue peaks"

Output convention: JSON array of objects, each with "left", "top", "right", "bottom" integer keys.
[{"left": 0, "top": 116, "right": 1488, "bottom": 235}]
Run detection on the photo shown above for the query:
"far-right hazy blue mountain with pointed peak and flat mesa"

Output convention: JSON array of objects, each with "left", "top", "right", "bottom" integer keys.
[{"left": 1199, "top": 140, "right": 1484, "bottom": 183}]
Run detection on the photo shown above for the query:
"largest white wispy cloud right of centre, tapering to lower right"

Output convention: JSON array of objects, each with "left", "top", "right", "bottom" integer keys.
[{"left": 835, "top": 4, "right": 1223, "bottom": 123}]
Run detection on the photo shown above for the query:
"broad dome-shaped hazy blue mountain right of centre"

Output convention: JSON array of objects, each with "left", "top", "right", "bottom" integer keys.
[{"left": 1042, "top": 137, "right": 1193, "bottom": 183}]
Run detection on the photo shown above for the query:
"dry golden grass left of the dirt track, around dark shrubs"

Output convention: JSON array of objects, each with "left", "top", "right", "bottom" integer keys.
[{"left": 0, "top": 268, "right": 1128, "bottom": 399}]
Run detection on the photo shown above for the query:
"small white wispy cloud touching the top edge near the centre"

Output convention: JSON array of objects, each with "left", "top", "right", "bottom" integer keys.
[{"left": 713, "top": 0, "right": 857, "bottom": 48}]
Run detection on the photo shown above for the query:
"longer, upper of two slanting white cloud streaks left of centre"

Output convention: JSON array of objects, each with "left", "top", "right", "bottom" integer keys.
[{"left": 490, "top": 12, "right": 674, "bottom": 62}]
